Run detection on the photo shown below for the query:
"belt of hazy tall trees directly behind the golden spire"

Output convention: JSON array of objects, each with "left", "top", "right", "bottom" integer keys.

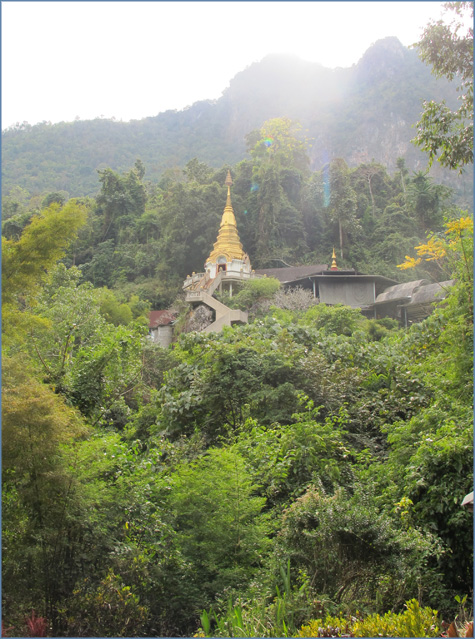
[{"left": 2, "top": 118, "right": 462, "bottom": 316}]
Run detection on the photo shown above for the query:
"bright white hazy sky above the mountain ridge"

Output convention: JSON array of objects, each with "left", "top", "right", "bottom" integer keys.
[{"left": 1, "top": 0, "right": 454, "bottom": 128}]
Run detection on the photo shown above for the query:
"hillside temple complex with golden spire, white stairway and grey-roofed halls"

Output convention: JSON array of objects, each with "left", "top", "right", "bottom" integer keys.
[{"left": 149, "top": 171, "right": 453, "bottom": 347}]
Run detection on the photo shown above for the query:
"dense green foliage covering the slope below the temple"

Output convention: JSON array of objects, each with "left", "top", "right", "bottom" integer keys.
[{"left": 3, "top": 208, "right": 473, "bottom": 636}]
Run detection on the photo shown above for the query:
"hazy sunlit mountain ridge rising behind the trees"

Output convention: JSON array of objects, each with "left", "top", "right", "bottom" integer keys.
[{"left": 2, "top": 37, "right": 472, "bottom": 196}]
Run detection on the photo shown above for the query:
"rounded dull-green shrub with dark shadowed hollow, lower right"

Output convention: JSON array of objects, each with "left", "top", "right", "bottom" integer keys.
[{"left": 276, "top": 484, "right": 440, "bottom": 608}]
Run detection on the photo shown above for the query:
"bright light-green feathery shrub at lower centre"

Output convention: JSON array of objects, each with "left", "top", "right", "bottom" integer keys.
[{"left": 168, "top": 448, "right": 269, "bottom": 609}]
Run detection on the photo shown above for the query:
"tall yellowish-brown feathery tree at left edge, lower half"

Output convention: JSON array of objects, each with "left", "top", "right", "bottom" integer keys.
[{"left": 2, "top": 355, "right": 86, "bottom": 623}]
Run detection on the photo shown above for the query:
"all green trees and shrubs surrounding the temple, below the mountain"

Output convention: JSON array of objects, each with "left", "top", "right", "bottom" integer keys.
[{"left": 2, "top": 6, "right": 473, "bottom": 637}]
